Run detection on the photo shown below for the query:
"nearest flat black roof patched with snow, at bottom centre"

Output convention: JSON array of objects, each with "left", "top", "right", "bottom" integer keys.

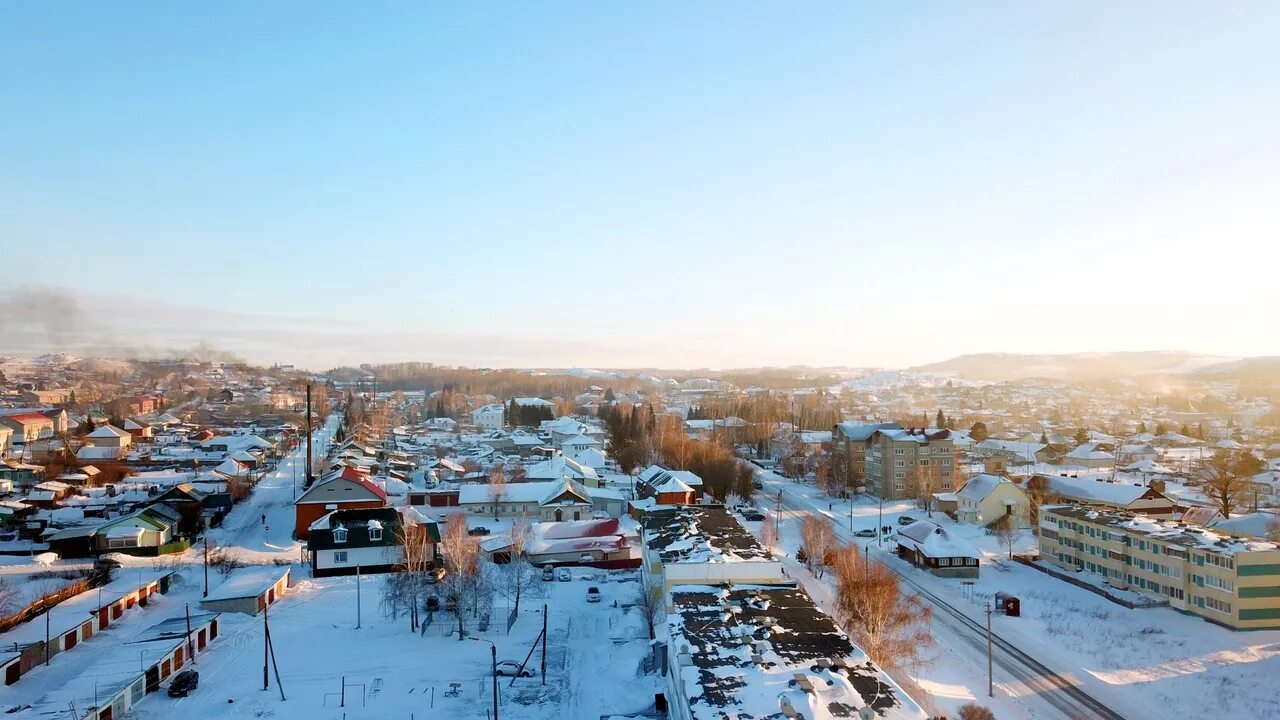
[{"left": 667, "top": 585, "right": 927, "bottom": 720}]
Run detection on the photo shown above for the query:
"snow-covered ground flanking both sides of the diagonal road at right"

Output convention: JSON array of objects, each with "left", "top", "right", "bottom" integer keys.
[{"left": 758, "top": 471, "right": 1280, "bottom": 720}]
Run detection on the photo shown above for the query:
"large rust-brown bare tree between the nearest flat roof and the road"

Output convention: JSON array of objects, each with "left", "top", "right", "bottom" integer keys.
[{"left": 835, "top": 544, "right": 933, "bottom": 670}]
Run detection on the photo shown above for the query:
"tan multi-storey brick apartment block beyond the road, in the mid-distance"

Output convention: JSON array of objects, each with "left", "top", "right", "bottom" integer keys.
[{"left": 865, "top": 428, "right": 956, "bottom": 500}]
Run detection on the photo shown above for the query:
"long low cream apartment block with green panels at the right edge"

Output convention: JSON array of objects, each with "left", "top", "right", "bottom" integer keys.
[{"left": 1039, "top": 506, "right": 1280, "bottom": 630}]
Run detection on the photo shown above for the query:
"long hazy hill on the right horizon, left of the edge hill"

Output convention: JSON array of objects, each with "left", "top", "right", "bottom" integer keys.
[{"left": 910, "top": 350, "right": 1233, "bottom": 382}]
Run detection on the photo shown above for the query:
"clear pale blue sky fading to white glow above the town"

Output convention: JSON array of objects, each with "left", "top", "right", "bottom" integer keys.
[{"left": 0, "top": 7, "right": 1280, "bottom": 369}]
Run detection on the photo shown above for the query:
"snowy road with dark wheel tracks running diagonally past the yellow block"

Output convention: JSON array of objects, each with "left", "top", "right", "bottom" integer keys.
[{"left": 756, "top": 471, "right": 1124, "bottom": 720}]
